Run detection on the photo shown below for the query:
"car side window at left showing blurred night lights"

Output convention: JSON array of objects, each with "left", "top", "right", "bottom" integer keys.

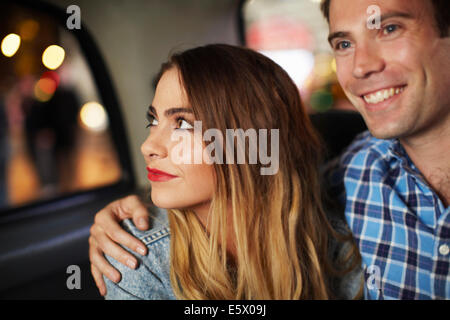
[{"left": 0, "top": 3, "right": 123, "bottom": 211}]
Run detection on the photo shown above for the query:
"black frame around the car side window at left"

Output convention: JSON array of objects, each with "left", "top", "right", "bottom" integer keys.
[{"left": 0, "top": 0, "right": 136, "bottom": 224}]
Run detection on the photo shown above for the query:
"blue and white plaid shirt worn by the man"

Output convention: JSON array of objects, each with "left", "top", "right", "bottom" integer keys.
[{"left": 328, "top": 131, "right": 450, "bottom": 299}]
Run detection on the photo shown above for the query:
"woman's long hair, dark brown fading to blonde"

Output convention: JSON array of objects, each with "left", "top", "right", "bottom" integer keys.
[{"left": 155, "top": 45, "right": 358, "bottom": 299}]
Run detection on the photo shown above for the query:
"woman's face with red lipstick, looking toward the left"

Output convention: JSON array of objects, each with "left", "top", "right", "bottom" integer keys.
[{"left": 141, "top": 68, "right": 215, "bottom": 218}]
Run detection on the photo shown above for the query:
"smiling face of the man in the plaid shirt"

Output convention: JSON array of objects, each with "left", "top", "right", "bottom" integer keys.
[{"left": 330, "top": 0, "right": 450, "bottom": 139}]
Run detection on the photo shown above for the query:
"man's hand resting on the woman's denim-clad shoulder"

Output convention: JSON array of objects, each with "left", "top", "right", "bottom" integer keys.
[{"left": 89, "top": 195, "right": 149, "bottom": 296}]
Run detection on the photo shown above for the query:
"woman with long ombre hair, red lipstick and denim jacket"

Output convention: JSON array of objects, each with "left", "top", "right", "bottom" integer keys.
[{"left": 90, "top": 45, "right": 358, "bottom": 299}]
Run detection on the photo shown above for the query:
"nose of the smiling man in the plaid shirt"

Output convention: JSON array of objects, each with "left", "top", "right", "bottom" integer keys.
[{"left": 353, "top": 43, "right": 386, "bottom": 79}]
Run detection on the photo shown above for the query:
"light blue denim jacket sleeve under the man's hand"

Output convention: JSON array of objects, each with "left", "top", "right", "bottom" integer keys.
[{"left": 104, "top": 211, "right": 175, "bottom": 300}]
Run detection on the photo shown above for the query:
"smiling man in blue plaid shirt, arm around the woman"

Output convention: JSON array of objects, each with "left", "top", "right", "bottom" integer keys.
[{"left": 90, "top": 0, "right": 450, "bottom": 299}]
